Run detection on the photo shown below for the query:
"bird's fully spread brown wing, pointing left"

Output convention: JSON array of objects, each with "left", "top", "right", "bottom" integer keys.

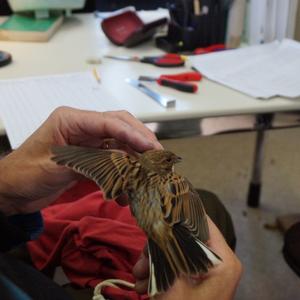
[{"left": 51, "top": 146, "right": 137, "bottom": 199}]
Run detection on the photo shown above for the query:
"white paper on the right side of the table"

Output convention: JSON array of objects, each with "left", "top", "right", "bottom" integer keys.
[{"left": 190, "top": 39, "right": 300, "bottom": 98}]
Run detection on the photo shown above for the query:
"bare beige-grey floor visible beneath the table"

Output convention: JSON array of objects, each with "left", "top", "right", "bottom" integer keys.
[{"left": 163, "top": 129, "right": 300, "bottom": 300}]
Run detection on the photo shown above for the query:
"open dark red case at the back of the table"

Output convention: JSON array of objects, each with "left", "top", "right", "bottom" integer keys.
[{"left": 101, "top": 11, "right": 168, "bottom": 47}]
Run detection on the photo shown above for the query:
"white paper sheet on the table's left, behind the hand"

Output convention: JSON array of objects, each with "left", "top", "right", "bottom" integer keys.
[{"left": 0, "top": 72, "right": 122, "bottom": 148}]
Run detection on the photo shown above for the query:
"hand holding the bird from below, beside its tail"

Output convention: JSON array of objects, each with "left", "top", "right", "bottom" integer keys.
[{"left": 133, "top": 217, "right": 242, "bottom": 300}]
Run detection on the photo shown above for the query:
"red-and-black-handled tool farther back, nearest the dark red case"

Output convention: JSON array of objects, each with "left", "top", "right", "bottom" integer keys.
[{"left": 104, "top": 53, "right": 186, "bottom": 68}]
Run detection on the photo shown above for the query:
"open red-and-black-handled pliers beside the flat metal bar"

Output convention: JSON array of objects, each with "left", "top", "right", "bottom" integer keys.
[{"left": 138, "top": 72, "right": 202, "bottom": 93}]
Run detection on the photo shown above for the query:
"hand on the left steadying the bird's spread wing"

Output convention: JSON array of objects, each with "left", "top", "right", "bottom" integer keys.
[{"left": 0, "top": 107, "right": 162, "bottom": 215}]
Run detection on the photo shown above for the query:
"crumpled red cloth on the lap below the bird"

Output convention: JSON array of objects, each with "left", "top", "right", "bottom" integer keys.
[{"left": 28, "top": 181, "right": 146, "bottom": 300}]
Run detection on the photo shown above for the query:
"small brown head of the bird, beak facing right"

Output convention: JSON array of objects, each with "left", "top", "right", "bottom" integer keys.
[{"left": 140, "top": 150, "right": 181, "bottom": 174}]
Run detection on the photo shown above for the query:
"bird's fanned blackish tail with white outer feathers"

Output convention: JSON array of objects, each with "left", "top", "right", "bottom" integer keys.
[{"left": 148, "top": 224, "right": 221, "bottom": 296}]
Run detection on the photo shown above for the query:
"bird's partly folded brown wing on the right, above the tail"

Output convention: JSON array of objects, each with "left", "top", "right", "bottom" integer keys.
[{"left": 162, "top": 173, "right": 209, "bottom": 242}]
